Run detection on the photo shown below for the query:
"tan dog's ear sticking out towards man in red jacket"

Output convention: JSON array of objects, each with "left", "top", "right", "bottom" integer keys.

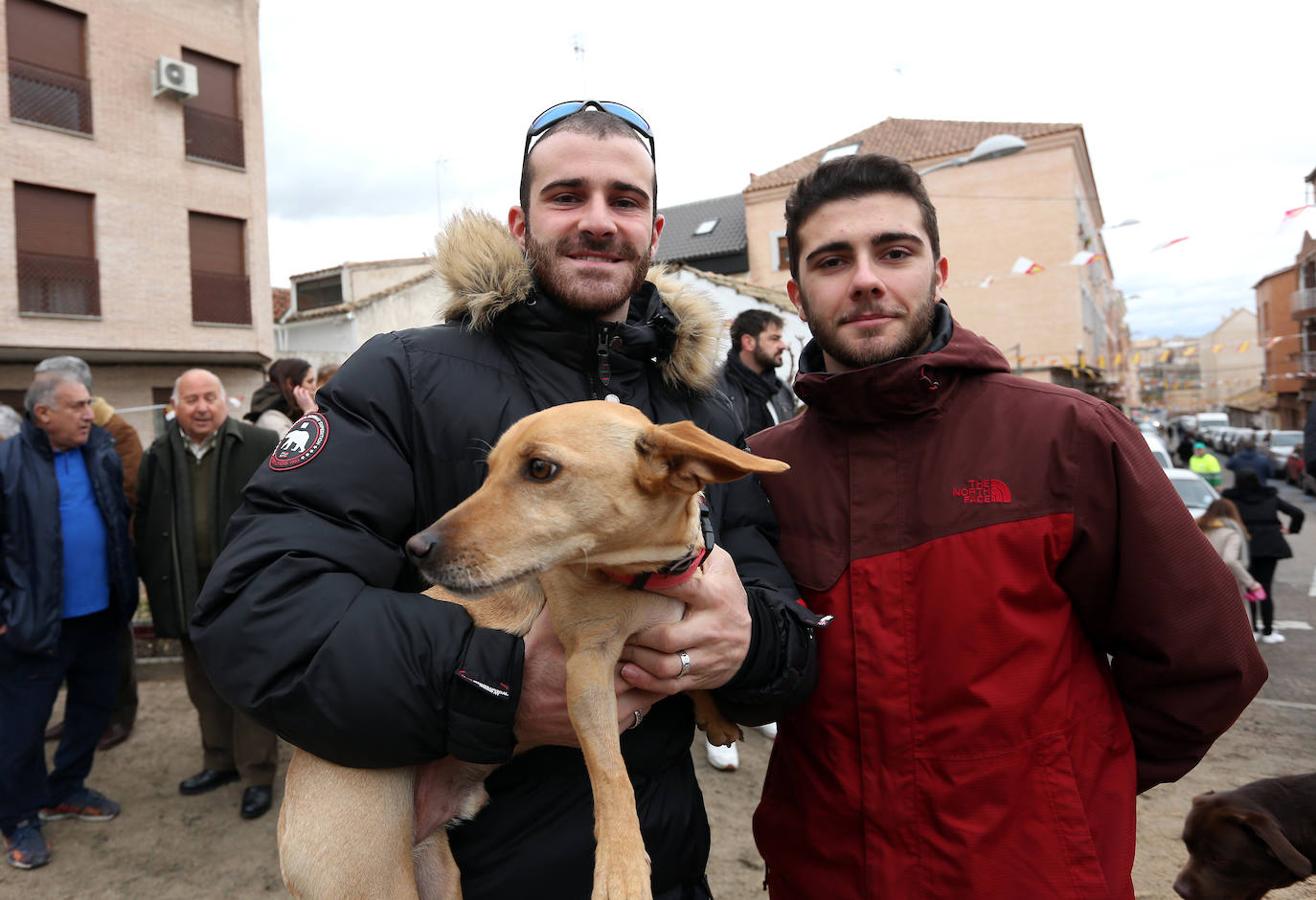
[{"left": 636, "top": 421, "right": 790, "bottom": 493}]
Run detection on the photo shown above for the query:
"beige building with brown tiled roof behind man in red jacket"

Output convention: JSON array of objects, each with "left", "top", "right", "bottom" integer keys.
[{"left": 745, "top": 118, "right": 1136, "bottom": 405}]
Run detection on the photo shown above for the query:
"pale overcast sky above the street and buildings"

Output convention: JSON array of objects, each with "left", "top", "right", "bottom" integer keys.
[{"left": 261, "top": 0, "right": 1316, "bottom": 337}]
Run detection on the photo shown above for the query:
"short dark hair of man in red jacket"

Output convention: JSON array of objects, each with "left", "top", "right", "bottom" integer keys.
[{"left": 786, "top": 153, "right": 941, "bottom": 283}]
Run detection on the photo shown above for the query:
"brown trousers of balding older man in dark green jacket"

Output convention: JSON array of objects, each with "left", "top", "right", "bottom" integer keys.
[{"left": 180, "top": 638, "right": 279, "bottom": 787}]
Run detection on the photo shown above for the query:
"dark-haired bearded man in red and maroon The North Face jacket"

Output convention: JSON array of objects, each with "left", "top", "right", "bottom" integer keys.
[{"left": 750, "top": 155, "right": 1266, "bottom": 900}]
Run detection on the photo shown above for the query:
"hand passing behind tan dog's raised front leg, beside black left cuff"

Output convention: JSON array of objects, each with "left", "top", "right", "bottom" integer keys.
[{"left": 512, "top": 609, "right": 663, "bottom": 753}]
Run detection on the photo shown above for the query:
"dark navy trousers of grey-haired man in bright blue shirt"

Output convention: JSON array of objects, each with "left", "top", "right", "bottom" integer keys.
[{"left": 0, "top": 611, "right": 120, "bottom": 836}]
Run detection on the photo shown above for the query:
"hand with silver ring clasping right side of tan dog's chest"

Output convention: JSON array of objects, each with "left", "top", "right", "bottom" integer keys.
[{"left": 621, "top": 547, "right": 751, "bottom": 695}]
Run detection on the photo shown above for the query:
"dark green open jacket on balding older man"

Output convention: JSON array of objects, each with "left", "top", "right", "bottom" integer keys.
[{"left": 133, "top": 416, "right": 279, "bottom": 638}]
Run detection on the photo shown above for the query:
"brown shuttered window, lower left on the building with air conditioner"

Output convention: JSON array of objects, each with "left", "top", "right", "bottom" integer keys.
[{"left": 13, "top": 183, "right": 100, "bottom": 316}]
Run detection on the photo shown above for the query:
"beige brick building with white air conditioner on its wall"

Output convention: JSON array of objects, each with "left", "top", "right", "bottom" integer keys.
[{"left": 0, "top": 0, "right": 274, "bottom": 441}]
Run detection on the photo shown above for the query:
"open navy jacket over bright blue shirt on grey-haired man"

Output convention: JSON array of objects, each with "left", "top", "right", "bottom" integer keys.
[{"left": 0, "top": 418, "right": 137, "bottom": 654}]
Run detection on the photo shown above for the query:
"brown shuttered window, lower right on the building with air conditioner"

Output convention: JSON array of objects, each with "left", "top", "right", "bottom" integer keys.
[{"left": 187, "top": 212, "right": 251, "bottom": 325}]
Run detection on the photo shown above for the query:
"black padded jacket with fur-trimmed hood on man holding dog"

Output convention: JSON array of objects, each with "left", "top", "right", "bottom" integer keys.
[{"left": 192, "top": 209, "right": 816, "bottom": 900}]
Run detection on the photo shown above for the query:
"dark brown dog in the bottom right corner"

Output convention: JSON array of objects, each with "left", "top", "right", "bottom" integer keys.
[{"left": 1174, "top": 774, "right": 1316, "bottom": 900}]
